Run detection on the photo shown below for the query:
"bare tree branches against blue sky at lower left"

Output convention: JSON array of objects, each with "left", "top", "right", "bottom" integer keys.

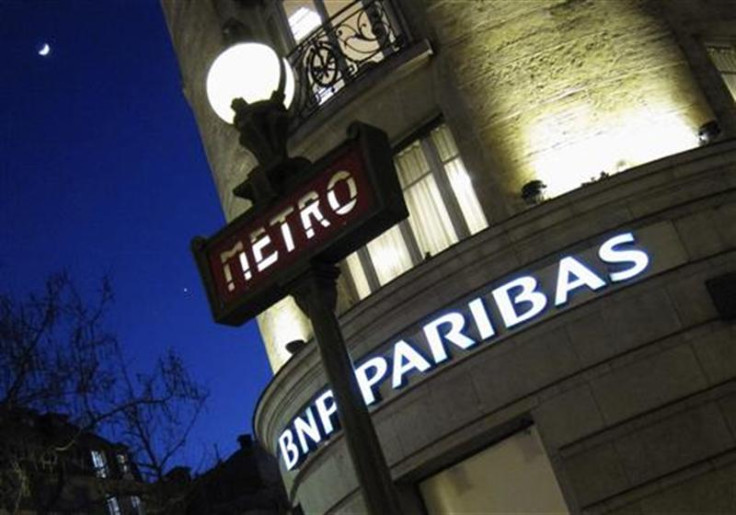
[{"left": 0, "top": 273, "right": 207, "bottom": 513}]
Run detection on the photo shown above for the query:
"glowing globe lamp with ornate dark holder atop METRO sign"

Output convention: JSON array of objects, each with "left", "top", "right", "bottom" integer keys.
[{"left": 207, "top": 42, "right": 309, "bottom": 204}]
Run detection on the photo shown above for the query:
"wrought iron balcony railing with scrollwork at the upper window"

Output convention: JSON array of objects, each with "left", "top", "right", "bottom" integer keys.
[{"left": 288, "top": 0, "right": 408, "bottom": 128}]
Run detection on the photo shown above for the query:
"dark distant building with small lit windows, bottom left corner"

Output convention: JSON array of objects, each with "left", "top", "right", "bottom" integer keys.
[{"left": 0, "top": 409, "right": 146, "bottom": 515}]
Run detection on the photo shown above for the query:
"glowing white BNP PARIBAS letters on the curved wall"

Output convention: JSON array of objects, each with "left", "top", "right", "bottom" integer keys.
[{"left": 278, "top": 232, "right": 649, "bottom": 470}]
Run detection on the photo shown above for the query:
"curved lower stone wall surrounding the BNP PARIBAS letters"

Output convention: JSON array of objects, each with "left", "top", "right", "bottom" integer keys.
[{"left": 255, "top": 141, "right": 736, "bottom": 513}]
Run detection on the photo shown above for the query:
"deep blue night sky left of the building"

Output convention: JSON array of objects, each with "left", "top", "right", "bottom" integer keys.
[{"left": 0, "top": 0, "right": 271, "bottom": 468}]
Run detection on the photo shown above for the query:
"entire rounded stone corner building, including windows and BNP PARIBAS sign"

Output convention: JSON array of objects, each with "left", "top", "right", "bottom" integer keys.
[{"left": 162, "top": 0, "right": 736, "bottom": 514}]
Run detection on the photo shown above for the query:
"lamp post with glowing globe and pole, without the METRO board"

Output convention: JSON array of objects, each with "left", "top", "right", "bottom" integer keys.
[{"left": 207, "top": 43, "right": 401, "bottom": 515}]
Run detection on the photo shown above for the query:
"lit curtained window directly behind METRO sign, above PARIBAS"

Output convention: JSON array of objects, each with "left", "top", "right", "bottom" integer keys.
[{"left": 346, "top": 124, "right": 488, "bottom": 299}]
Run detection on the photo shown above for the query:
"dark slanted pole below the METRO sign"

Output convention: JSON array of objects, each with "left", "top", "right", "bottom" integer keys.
[{"left": 290, "top": 263, "right": 401, "bottom": 515}]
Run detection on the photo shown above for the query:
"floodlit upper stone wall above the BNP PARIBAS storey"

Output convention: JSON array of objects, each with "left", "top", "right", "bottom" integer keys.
[{"left": 162, "top": 0, "right": 723, "bottom": 371}]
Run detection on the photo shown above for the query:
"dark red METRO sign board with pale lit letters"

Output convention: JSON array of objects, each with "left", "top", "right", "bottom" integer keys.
[{"left": 192, "top": 124, "right": 408, "bottom": 326}]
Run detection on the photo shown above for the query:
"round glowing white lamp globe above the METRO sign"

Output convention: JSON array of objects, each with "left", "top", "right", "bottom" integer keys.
[{"left": 207, "top": 43, "right": 295, "bottom": 124}]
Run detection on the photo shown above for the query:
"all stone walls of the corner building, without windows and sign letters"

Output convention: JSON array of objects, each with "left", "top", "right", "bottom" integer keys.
[{"left": 161, "top": 0, "right": 736, "bottom": 513}]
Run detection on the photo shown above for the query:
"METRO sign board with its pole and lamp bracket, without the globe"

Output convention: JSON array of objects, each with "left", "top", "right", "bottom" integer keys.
[{"left": 192, "top": 123, "right": 408, "bottom": 515}]
